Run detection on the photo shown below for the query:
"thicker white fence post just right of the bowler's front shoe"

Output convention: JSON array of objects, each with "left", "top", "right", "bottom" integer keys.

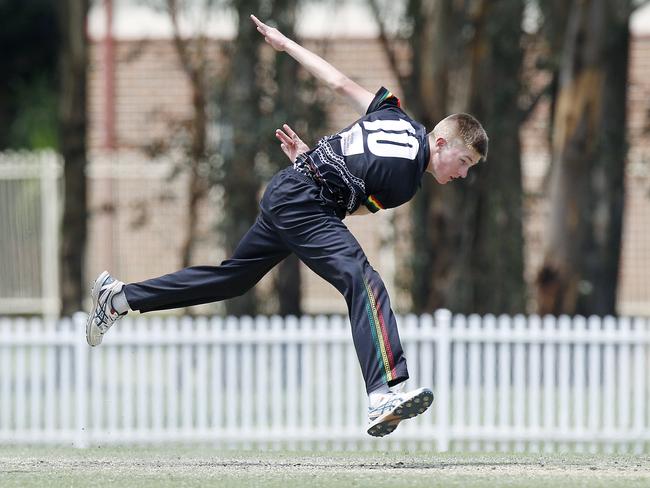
[{"left": 435, "top": 309, "right": 451, "bottom": 452}]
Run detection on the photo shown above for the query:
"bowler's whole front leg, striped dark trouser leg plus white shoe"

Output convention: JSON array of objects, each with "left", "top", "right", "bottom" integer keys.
[{"left": 262, "top": 171, "right": 433, "bottom": 436}]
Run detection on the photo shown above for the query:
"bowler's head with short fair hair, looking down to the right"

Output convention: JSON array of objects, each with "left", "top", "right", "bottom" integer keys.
[{"left": 427, "top": 113, "right": 488, "bottom": 185}]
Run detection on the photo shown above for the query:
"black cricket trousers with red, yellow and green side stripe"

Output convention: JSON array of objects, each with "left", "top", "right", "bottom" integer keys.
[{"left": 125, "top": 167, "right": 408, "bottom": 393}]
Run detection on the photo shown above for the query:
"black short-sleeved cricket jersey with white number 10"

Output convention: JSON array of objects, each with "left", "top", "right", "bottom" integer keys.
[{"left": 296, "top": 87, "right": 429, "bottom": 215}]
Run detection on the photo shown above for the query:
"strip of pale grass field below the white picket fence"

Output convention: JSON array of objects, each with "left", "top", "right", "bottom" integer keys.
[{"left": 0, "top": 446, "right": 650, "bottom": 488}]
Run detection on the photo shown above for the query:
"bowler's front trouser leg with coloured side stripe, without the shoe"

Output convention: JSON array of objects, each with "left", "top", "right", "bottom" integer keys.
[{"left": 267, "top": 186, "right": 408, "bottom": 393}]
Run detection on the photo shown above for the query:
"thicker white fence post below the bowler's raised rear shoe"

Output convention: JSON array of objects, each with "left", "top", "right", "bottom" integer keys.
[{"left": 71, "top": 312, "right": 89, "bottom": 448}]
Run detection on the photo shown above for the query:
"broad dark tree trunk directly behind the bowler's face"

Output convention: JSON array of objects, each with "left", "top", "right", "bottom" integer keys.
[{"left": 450, "top": 0, "right": 526, "bottom": 314}]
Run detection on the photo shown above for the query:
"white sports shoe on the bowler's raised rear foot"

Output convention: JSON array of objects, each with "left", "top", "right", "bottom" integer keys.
[{"left": 86, "top": 271, "right": 126, "bottom": 346}]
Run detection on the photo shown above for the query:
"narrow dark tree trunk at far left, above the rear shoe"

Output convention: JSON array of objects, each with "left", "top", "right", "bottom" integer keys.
[{"left": 57, "top": 0, "right": 88, "bottom": 315}]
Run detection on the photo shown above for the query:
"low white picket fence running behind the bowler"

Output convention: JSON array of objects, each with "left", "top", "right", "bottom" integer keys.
[{"left": 0, "top": 310, "right": 650, "bottom": 453}]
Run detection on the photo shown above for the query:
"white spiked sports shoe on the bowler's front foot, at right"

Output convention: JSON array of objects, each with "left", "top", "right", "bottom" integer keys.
[{"left": 367, "top": 388, "right": 433, "bottom": 437}]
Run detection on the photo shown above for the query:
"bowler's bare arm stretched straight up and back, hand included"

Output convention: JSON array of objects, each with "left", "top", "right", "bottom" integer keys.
[{"left": 251, "top": 15, "right": 374, "bottom": 114}]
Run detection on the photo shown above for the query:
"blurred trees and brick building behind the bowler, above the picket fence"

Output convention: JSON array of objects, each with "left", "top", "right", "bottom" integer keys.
[{"left": 0, "top": 0, "right": 650, "bottom": 315}]
